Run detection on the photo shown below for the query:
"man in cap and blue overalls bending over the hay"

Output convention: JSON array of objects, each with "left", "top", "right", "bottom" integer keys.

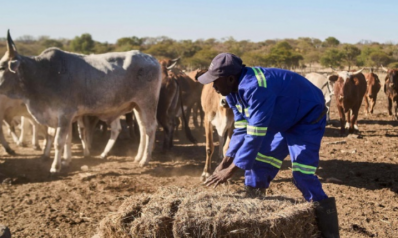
[{"left": 198, "top": 53, "right": 339, "bottom": 237}]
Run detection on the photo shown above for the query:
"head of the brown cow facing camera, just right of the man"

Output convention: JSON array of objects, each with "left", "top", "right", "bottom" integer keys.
[{"left": 329, "top": 69, "right": 363, "bottom": 106}]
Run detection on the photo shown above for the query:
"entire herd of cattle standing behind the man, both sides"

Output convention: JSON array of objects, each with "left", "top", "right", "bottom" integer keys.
[{"left": 0, "top": 32, "right": 398, "bottom": 180}]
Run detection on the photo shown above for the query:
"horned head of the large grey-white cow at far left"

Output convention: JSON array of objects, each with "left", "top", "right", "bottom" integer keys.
[{"left": 0, "top": 31, "right": 21, "bottom": 93}]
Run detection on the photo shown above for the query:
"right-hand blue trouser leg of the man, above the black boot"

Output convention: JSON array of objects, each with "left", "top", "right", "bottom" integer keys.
[{"left": 283, "top": 118, "right": 328, "bottom": 201}]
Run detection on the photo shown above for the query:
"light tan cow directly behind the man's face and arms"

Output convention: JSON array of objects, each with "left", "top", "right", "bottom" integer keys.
[{"left": 201, "top": 84, "right": 234, "bottom": 181}]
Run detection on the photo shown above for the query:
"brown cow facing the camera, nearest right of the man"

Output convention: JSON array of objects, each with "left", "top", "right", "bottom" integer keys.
[{"left": 329, "top": 69, "right": 366, "bottom": 135}]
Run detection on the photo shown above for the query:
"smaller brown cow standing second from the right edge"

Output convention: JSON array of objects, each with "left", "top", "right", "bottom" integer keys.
[{"left": 364, "top": 69, "right": 381, "bottom": 115}]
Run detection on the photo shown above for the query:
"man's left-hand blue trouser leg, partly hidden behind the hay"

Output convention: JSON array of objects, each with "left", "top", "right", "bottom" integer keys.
[{"left": 245, "top": 132, "right": 289, "bottom": 188}]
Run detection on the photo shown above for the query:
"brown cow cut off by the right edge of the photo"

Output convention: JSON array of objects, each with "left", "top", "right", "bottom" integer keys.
[{"left": 382, "top": 66, "right": 398, "bottom": 120}]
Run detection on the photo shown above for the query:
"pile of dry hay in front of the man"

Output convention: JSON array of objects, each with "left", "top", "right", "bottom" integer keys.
[{"left": 98, "top": 187, "right": 319, "bottom": 238}]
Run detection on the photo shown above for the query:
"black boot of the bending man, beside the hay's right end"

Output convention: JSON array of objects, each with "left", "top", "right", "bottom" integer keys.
[{"left": 314, "top": 197, "right": 340, "bottom": 238}]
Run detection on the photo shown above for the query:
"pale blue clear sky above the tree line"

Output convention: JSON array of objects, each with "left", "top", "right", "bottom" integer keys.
[{"left": 0, "top": 0, "right": 398, "bottom": 43}]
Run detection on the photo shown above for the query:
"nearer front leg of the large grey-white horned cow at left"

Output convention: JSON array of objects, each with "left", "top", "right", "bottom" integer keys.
[{"left": 50, "top": 116, "right": 71, "bottom": 174}]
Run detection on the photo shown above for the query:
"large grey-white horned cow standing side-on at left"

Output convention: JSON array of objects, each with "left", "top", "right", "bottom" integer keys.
[{"left": 0, "top": 32, "right": 161, "bottom": 173}]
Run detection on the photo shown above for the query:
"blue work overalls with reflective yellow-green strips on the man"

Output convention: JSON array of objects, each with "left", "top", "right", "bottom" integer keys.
[{"left": 226, "top": 67, "right": 327, "bottom": 201}]
